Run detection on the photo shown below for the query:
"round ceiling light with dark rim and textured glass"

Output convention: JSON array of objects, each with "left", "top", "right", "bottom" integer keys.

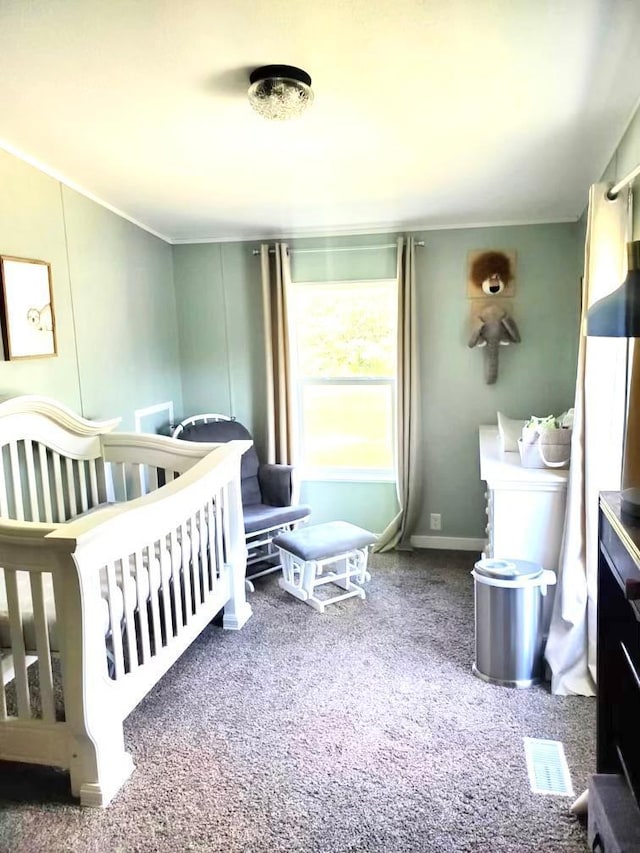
[{"left": 249, "top": 65, "right": 313, "bottom": 120}]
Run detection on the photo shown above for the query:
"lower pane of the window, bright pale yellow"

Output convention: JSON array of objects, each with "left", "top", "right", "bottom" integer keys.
[{"left": 302, "top": 384, "right": 393, "bottom": 471}]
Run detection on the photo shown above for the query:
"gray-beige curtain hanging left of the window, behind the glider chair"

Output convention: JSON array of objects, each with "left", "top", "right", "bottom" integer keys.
[{"left": 260, "top": 243, "right": 295, "bottom": 465}]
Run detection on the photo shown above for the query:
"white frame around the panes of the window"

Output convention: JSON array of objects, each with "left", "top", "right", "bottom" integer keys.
[{"left": 288, "top": 278, "right": 398, "bottom": 482}]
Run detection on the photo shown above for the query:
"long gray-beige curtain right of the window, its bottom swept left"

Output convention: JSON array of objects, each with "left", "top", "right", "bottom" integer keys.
[{"left": 374, "top": 237, "right": 423, "bottom": 551}]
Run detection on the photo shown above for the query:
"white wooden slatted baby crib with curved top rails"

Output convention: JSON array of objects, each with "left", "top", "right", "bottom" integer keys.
[{"left": 0, "top": 396, "right": 251, "bottom": 806}]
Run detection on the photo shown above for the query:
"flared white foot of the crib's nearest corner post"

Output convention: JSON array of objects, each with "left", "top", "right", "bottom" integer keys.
[{"left": 69, "top": 722, "right": 134, "bottom": 807}]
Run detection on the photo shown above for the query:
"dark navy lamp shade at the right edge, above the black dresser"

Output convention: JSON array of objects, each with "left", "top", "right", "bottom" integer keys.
[{"left": 587, "top": 240, "right": 640, "bottom": 338}]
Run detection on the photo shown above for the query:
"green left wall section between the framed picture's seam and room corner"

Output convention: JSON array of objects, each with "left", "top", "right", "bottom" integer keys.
[{"left": 63, "top": 188, "right": 182, "bottom": 430}]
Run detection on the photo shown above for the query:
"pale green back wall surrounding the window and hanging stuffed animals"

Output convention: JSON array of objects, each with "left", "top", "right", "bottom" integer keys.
[{"left": 174, "top": 223, "right": 582, "bottom": 539}]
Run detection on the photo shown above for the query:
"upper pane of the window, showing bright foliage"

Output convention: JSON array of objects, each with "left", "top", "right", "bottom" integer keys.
[{"left": 293, "top": 282, "right": 397, "bottom": 378}]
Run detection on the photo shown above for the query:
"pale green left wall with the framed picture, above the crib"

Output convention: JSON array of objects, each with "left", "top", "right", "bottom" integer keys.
[{"left": 0, "top": 151, "right": 182, "bottom": 429}]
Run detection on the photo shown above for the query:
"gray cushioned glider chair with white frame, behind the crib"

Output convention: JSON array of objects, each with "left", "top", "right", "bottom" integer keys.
[{"left": 172, "top": 414, "right": 311, "bottom": 591}]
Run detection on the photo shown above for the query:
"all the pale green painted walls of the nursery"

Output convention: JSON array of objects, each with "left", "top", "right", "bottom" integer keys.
[{"left": 0, "top": 141, "right": 584, "bottom": 539}]
